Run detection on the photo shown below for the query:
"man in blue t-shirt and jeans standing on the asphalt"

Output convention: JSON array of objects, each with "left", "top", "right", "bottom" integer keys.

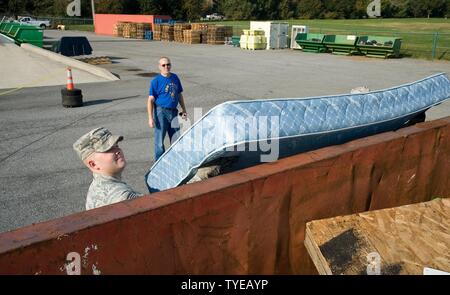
[{"left": 147, "top": 57, "right": 187, "bottom": 162}]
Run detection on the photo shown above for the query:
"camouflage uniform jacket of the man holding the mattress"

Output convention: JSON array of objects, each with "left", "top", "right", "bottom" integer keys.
[{"left": 86, "top": 173, "right": 142, "bottom": 210}]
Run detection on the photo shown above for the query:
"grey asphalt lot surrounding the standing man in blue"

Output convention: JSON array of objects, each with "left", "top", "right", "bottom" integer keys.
[{"left": 0, "top": 30, "right": 450, "bottom": 232}]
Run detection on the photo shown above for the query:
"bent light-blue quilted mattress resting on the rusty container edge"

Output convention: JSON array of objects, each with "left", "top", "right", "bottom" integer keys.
[{"left": 145, "top": 73, "right": 450, "bottom": 193}]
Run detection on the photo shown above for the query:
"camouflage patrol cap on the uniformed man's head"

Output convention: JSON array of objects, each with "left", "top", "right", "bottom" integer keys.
[{"left": 73, "top": 127, "right": 123, "bottom": 161}]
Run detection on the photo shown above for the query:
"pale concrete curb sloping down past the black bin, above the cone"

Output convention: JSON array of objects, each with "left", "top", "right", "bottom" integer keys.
[{"left": 20, "top": 43, "right": 120, "bottom": 81}]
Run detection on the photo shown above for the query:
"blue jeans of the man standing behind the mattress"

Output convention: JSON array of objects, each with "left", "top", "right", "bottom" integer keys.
[{"left": 153, "top": 105, "right": 180, "bottom": 162}]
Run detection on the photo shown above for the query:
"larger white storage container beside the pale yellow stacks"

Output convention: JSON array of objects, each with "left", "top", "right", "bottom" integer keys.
[{"left": 250, "top": 21, "right": 289, "bottom": 49}]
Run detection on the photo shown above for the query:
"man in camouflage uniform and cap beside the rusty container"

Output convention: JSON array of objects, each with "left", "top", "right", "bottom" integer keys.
[{"left": 73, "top": 127, "right": 142, "bottom": 210}]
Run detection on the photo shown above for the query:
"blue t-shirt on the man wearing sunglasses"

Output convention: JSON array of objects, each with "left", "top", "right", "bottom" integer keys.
[{"left": 148, "top": 73, "right": 183, "bottom": 109}]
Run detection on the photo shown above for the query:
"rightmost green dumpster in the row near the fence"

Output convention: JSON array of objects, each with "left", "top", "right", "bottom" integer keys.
[{"left": 356, "top": 36, "right": 402, "bottom": 58}]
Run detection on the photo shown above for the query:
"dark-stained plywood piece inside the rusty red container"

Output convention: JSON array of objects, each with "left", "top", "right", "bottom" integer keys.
[{"left": 305, "top": 199, "right": 450, "bottom": 274}]
